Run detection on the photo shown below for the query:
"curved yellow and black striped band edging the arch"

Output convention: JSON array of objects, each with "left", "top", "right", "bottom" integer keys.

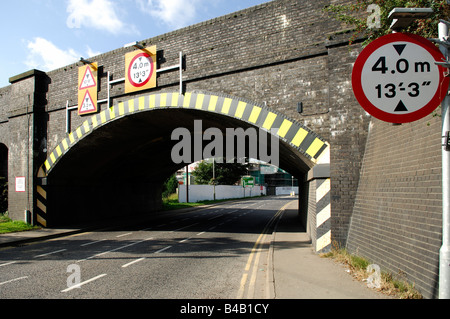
[{"left": 42, "top": 92, "right": 328, "bottom": 175}]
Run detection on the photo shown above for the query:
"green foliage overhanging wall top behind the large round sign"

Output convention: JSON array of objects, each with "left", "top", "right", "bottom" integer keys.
[{"left": 325, "top": 0, "right": 450, "bottom": 45}]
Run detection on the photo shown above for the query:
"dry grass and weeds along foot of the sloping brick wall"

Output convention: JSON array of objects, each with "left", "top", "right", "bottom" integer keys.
[{"left": 320, "top": 245, "right": 423, "bottom": 299}]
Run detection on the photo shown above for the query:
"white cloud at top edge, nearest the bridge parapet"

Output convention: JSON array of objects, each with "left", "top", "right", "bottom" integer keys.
[{"left": 137, "top": 0, "right": 202, "bottom": 28}]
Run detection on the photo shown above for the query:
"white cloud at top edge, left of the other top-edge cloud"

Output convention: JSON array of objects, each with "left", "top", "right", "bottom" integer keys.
[{"left": 66, "top": 0, "right": 139, "bottom": 34}]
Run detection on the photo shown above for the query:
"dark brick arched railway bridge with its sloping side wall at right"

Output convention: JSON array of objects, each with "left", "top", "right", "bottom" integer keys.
[{"left": 0, "top": 0, "right": 442, "bottom": 298}]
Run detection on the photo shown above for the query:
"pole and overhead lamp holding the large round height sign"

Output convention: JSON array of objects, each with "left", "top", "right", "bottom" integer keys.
[{"left": 389, "top": 8, "right": 450, "bottom": 299}]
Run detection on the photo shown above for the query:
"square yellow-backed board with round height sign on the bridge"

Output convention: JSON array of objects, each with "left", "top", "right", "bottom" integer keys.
[{"left": 125, "top": 46, "right": 156, "bottom": 93}]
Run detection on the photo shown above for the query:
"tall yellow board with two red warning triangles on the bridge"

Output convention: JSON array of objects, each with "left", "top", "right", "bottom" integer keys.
[{"left": 78, "top": 62, "right": 98, "bottom": 115}]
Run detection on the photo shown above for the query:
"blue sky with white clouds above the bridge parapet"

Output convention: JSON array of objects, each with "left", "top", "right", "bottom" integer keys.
[{"left": 0, "top": 0, "right": 269, "bottom": 87}]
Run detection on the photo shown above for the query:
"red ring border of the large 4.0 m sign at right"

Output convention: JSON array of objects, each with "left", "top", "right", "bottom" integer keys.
[{"left": 352, "top": 33, "right": 450, "bottom": 123}]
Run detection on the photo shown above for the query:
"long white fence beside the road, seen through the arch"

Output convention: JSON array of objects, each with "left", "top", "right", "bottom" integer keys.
[{"left": 178, "top": 185, "right": 266, "bottom": 203}]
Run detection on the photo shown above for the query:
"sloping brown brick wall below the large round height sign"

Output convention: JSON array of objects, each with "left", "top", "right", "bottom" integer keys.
[{"left": 347, "top": 115, "right": 442, "bottom": 298}]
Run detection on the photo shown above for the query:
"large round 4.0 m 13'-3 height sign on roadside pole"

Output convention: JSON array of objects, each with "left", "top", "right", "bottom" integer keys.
[{"left": 352, "top": 33, "right": 449, "bottom": 123}]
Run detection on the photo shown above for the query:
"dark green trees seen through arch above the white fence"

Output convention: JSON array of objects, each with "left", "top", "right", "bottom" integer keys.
[{"left": 192, "top": 161, "right": 247, "bottom": 185}]
